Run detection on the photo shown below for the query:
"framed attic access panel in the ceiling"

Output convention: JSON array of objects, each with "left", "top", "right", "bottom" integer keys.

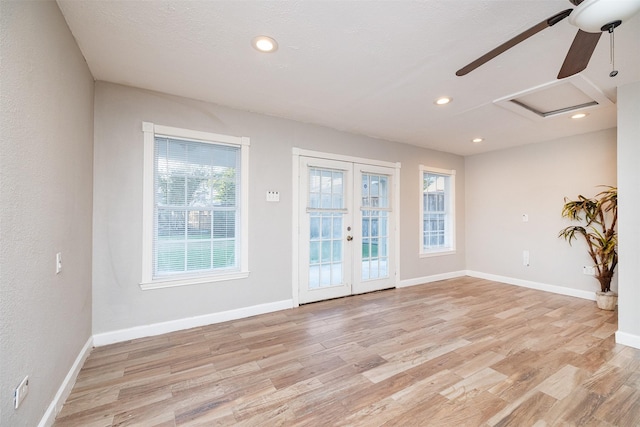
[{"left": 493, "top": 74, "right": 613, "bottom": 120}]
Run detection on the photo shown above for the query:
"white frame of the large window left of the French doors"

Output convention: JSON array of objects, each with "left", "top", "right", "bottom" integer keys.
[{"left": 140, "top": 122, "right": 251, "bottom": 290}]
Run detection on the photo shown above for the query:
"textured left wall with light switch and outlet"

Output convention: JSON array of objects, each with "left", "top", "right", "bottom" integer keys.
[{"left": 0, "top": 0, "right": 93, "bottom": 426}]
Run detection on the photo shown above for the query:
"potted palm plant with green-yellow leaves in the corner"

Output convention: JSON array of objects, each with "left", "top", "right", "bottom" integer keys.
[{"left": 558, "top": 186, "right": 618, "bottom": 310}]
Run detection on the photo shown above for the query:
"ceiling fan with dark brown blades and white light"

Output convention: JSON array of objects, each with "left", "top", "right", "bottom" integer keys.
[{"left": 456, "top": 0, "right": 640, "bottom": 79}]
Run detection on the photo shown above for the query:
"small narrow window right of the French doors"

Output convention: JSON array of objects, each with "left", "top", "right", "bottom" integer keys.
[{"left": 420, "top": 166, "right": 455, "bottom": 255}]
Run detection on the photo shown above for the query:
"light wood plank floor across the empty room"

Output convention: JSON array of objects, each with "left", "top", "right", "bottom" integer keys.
[{"left": 55, "top": 277, "right": 640, "bottom": 427}]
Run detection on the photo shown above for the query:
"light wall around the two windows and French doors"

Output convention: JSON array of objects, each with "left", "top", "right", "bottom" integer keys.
[{"left": 93, "top": 82, "right": 465, "bottom": 334}]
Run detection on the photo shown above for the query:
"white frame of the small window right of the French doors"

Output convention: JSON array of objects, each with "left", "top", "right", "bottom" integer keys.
[{"left": 419, "top": 165, "right": 456, "bottom": 258}]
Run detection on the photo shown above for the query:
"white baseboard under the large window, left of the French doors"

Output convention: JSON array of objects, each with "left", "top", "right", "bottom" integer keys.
[{"left": 93, "top": 300, "right": 293, "bottom": 347}]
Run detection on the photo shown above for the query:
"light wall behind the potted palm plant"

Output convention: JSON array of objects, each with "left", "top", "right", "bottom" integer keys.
[{"left": 466, "top": 129, "right": 616, "bottom": 296}]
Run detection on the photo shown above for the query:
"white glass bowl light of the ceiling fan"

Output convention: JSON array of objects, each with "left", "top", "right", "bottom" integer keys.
[{"left": 569, "top": 0, "right": 640, "bottom": 33}]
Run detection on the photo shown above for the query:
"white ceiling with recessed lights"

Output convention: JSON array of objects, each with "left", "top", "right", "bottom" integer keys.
[{"left": 58, "top": 0, "right": 640, "bottom": 155}]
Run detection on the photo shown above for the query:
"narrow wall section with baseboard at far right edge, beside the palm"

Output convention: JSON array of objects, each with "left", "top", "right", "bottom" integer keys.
[{"left": 616, "top": 82, "right": 640, "bottom": 348}]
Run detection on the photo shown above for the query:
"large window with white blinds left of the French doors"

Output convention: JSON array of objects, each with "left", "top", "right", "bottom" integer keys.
[{"left": 142, "top": 124, "right": 248, "bottom": 288}]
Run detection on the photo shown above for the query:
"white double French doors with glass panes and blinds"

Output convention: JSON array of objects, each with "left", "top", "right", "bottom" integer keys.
[{"left": 298, "top": 156, "right": 396, "bottom": 303}]
